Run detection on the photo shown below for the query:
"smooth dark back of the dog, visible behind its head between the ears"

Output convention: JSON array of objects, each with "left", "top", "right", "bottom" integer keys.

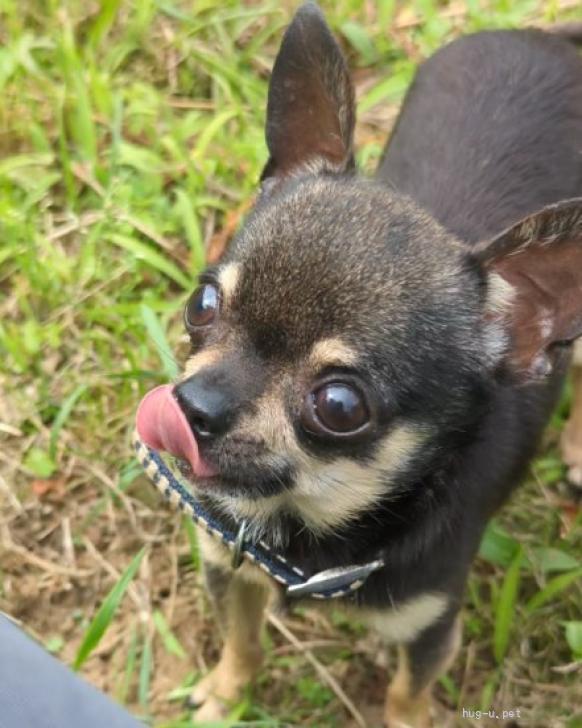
[{"left": 384, "top": 30, "right": 582, "bottom": 244}]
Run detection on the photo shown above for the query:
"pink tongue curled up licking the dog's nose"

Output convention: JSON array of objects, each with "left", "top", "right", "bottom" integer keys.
[{"left": 135, "top": 384, "right": 216, "bottom": 478}]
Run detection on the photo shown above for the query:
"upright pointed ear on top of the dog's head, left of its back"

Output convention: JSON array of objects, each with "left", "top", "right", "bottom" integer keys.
[{"left": 262, "top": 2, "right": 355, "bottom": 185}]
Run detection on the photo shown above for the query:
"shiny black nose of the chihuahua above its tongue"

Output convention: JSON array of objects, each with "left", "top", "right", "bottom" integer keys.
[{"left": 174, "top": 372, "right": 235, "bottom": 440}]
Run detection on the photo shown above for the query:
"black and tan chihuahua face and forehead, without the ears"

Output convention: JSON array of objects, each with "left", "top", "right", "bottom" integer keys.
[{"left": 178, "top": 178, "right": 492, "bottom": 530}]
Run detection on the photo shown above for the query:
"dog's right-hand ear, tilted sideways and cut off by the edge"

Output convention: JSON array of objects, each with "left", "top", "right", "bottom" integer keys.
[{"left": 475, "top": 198, "right": 582, "bottom": 378}]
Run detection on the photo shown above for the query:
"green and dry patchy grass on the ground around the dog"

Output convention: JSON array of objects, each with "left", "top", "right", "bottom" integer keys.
[{"left": 0, "top": 0, "right": 582, "bottom": 728}]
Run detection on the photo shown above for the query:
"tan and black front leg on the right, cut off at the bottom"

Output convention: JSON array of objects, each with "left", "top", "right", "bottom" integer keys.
[{"left": 384, "top": 615, "right": 461, "bottom": 728}]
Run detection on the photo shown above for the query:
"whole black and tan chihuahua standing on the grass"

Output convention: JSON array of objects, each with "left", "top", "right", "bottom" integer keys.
[{"left": 136, "top": 3, "right": 582, "bottom": 728}]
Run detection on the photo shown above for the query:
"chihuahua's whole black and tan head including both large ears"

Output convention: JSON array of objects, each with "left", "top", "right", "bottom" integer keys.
[{"left": 138, "top": 4, "right": 582, "bottom": 533}]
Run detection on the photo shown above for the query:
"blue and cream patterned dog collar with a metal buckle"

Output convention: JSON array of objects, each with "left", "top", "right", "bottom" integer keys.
[{"left": 133, "top": 432, "right": 384, "bottom": 599}]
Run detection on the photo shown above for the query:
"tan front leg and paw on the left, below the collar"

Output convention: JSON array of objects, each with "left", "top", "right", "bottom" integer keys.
[{"left": 189, "top": 536, "right": 269, "bottom": 722}]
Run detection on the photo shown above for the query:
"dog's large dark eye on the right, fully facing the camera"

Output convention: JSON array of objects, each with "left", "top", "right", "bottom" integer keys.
[{"left": 304, "top": 382, "right": 370, "bottom": 434}]
